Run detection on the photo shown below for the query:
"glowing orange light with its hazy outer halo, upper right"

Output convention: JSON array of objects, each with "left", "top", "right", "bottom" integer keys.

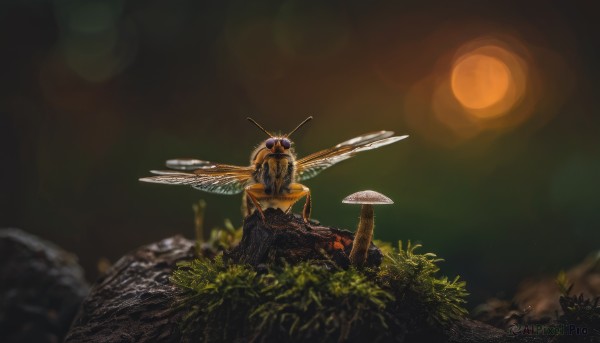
[{"left": 405, "top": 32, "right": 543, "bottom": 146}]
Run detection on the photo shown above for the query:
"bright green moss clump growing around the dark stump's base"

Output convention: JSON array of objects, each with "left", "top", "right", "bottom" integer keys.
[{"left": 172, "top": 244, "right": 466, "bottom": 342}]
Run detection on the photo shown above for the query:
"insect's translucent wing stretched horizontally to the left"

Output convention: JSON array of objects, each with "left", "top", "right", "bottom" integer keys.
[{"left": 140, "top": 162, "right": 254, "bottom": 194}]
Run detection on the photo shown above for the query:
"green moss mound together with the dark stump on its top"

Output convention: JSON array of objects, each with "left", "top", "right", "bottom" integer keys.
[{"left": 171, "top": 211, "right": 467, "bottom": 342}]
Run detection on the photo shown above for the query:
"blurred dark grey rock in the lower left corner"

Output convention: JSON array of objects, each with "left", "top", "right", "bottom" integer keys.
[{"left": 0, "top": 229, "right": 89, "bottom": 342}]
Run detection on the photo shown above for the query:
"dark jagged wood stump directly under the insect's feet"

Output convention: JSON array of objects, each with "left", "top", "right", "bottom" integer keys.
[{"left": 226, "top": 209, "right": 383, "bottom": 268}]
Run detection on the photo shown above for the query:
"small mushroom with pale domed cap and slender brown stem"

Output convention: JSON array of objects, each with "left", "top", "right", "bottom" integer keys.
[{"left": 342, "top": 191, "right": 394, "bottom": 267}]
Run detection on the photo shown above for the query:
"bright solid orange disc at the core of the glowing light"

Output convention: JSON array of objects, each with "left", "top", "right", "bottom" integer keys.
[{"left": 451, "top": 54, "right": 514, "bottom": 109}]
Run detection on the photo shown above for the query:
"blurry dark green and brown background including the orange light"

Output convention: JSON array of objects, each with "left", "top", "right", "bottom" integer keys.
[{"left": 0, "top": 0, "right": 600, "bottom": 305}]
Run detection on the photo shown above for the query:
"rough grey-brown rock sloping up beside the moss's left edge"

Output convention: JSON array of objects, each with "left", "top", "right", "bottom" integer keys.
[{"left": 65, "top": 236, "right": 194, "bottom": 342}]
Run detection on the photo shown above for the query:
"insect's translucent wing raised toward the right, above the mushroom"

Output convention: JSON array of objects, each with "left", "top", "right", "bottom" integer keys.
[{"left": 296, "top": 131, "right": 408, "bottom": 181}]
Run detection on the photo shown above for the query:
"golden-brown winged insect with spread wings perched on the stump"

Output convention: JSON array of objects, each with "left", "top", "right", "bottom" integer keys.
[{"left": 140, "top": 117, "right": 408, "bottom": 222}]
